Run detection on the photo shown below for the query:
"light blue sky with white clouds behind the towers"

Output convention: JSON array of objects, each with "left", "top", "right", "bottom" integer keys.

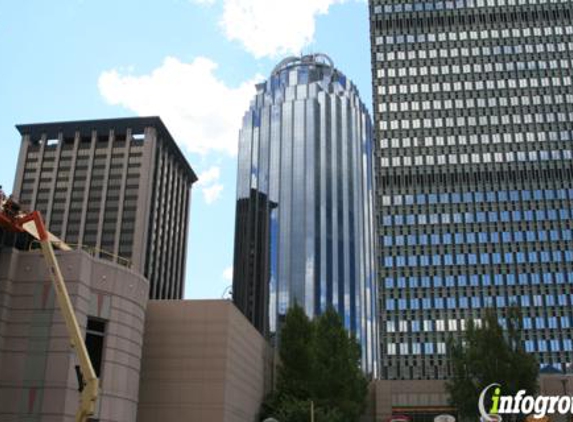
[{"left": 0, "top": 0, "right": 372, "bottom": 299}]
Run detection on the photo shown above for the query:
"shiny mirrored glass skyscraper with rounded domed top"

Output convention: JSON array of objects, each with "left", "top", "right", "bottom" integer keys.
[{"left": 233, "top": 54, "right": 378, "bottom": 373}]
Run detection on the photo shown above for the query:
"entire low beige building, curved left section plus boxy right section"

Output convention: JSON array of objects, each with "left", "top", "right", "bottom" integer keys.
[{"left": 0, "top": 237, "right": 273, "bottom": 422}]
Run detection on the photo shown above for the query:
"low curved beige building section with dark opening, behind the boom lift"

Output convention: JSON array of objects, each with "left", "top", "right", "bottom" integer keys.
[{"left": 0, "top": 248, "right": 149, "bottom": 422}]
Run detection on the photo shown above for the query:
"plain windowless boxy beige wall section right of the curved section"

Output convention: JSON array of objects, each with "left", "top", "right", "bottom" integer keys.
[{"left": 137, "top": 300, "right": 272, "bottom": 422}]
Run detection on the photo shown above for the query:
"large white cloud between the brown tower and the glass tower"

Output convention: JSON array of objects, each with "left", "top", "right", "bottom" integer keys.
[{"left": 98, "top": 57, "right": 260, "bottom": 155}]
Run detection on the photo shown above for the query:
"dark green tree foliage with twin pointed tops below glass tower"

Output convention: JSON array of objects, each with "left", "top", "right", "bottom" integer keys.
[{"left": 261, "top": 305, "right": 368, "bottom": 422}]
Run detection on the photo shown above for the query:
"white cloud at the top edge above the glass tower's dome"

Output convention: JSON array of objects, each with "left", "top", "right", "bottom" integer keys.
[{"left": 220, "top": 0, "right": 349, "bottom": 58}]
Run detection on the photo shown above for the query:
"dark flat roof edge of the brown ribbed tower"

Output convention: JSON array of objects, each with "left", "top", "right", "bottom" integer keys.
[{"left": 16, "top": 116, "right": 197, "bottom": 183}]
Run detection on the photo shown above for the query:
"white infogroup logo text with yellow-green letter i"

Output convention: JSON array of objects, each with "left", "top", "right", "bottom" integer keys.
[{"left": 478, "top": 383, "right": 573, "bottom": 422}]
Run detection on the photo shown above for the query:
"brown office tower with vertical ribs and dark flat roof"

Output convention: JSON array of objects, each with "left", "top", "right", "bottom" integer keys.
[{"left": 14, "top": 117, "right": 197, "bottom": 299}]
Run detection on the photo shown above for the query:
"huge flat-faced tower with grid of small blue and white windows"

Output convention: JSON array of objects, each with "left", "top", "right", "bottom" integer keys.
[{"left": 370, "top": 0, "right": 573, "bottom": 379}]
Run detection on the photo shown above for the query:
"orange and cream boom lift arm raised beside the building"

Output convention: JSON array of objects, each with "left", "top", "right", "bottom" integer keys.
[{"left": 0, "top": 187, "right": 99, "bottom": 422}]
